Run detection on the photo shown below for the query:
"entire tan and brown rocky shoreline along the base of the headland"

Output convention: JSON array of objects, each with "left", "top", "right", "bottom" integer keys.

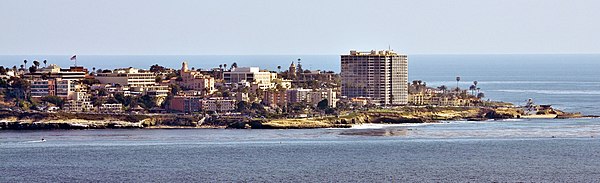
[{"left": 0, "top": 107, "right": 597, "bottom": 130}]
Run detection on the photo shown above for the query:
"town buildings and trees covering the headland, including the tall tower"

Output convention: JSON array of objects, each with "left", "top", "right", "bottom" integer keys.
[{"left": 0, "top": 50, "right": 483, "bottom": 117}]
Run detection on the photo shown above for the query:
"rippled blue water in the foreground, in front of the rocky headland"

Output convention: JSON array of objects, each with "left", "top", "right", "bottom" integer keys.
[{"left": 0, "top": 119, "right": 600, "bottom": 182}]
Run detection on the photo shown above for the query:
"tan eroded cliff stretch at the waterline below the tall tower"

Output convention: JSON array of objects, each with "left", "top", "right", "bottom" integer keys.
[{"left": 239, "top": 107, "right": 540, "bottom": 129}]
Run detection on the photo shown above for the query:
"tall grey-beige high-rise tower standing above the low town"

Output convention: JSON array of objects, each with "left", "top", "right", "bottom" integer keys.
[{"left": 341, "top": 50, "right": 408, "bottom": 105}]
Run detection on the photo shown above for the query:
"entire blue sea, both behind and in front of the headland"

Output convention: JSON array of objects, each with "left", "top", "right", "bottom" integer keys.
[{"left": 0, "top": 55, "right": 600, "bottom": 182}]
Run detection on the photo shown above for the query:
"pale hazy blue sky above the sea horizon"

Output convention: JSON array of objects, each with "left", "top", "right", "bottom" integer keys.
[{"left": 0, "top": 0, "right": 600, "bottom": 55}]
